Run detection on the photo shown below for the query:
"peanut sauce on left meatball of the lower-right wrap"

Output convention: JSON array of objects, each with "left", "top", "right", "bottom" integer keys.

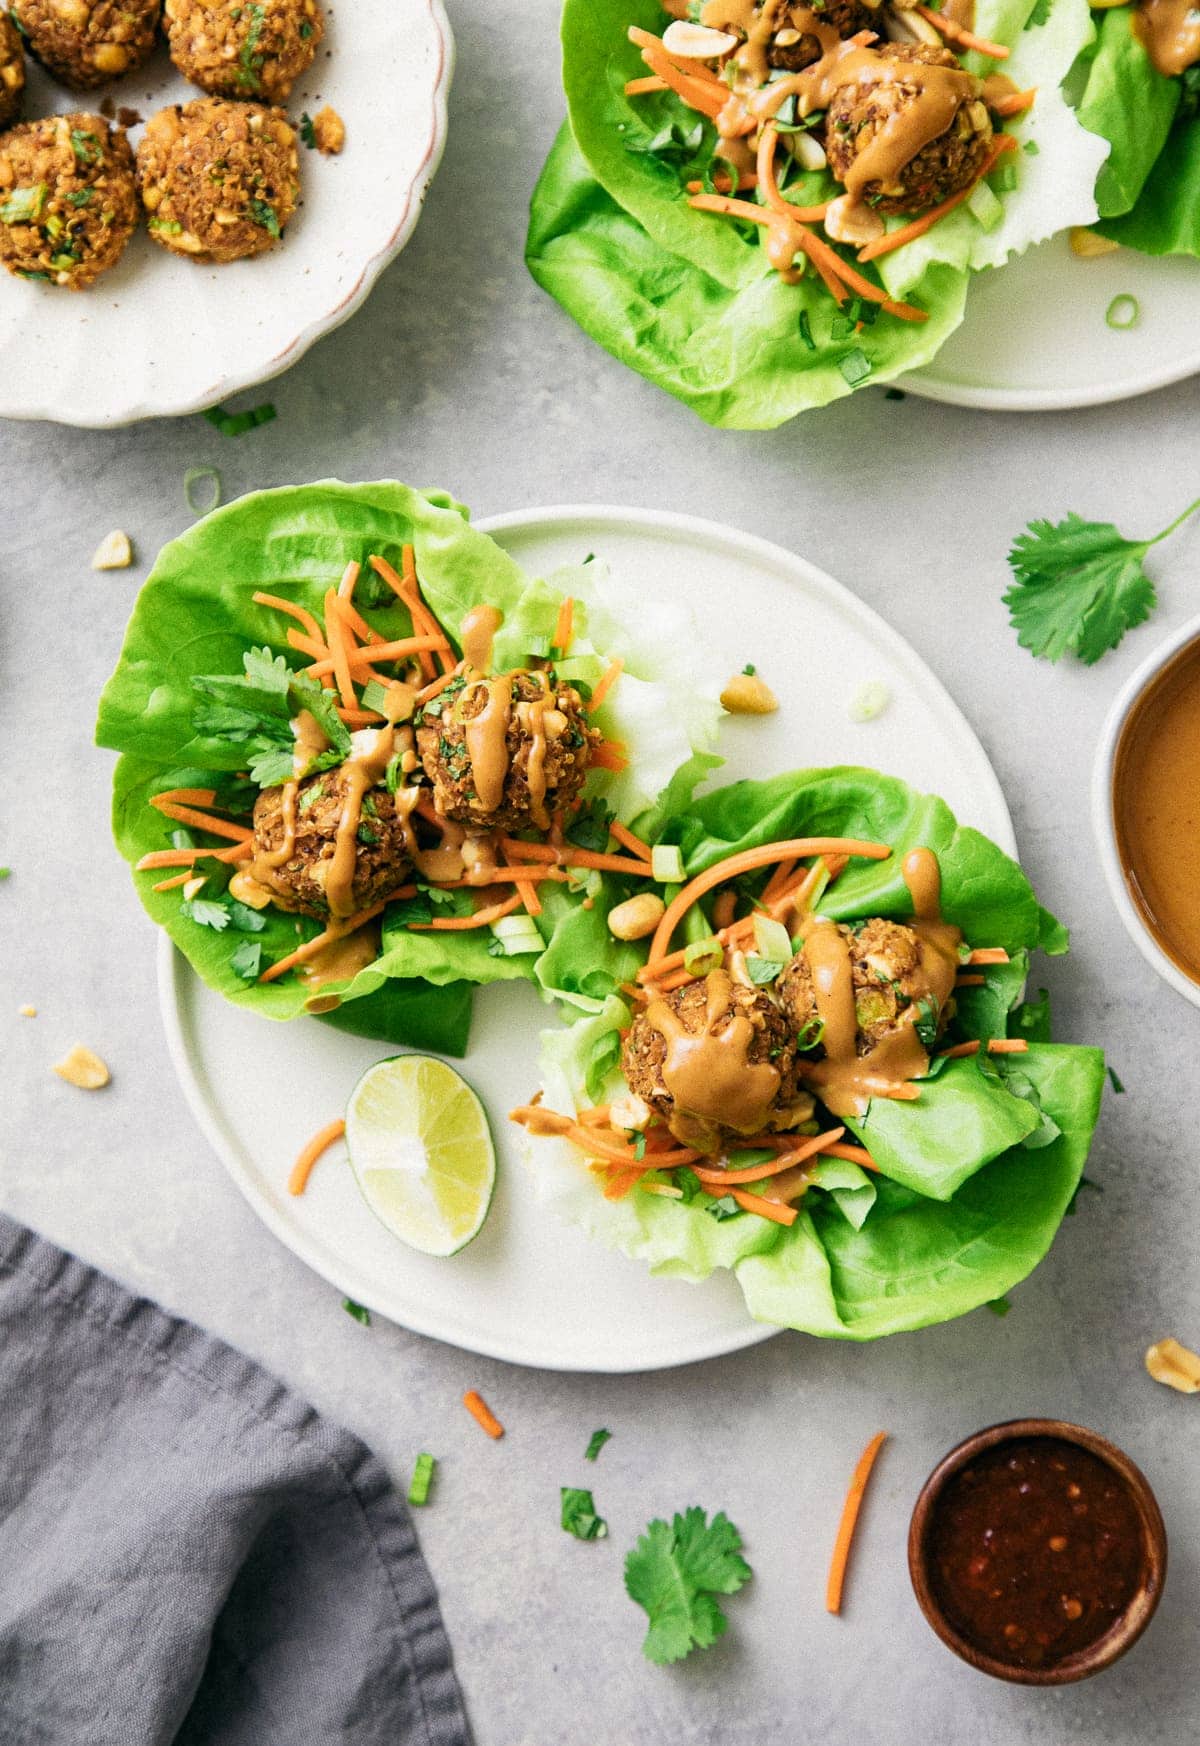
[{"left": 646, "top": 971, "right": 781, "bottom": 1151}]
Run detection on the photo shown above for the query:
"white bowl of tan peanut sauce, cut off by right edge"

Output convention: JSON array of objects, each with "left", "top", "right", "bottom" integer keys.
[{"left": 1092, "top": 618, "right": 1200, "bottom": 1006}]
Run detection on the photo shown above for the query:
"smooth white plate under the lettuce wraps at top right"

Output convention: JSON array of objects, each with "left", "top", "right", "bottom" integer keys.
[{"left": 901, "top": 236, "right": 1200, "bottom": 412}]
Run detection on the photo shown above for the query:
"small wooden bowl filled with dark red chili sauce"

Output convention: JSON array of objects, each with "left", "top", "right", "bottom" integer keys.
[{"left": 908, "top": 1419, "right": 1167, "bottom": 1685}]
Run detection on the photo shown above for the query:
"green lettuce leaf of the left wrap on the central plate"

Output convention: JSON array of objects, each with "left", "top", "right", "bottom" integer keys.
[{"left": 96, "top": 482, "right": 721, "bottom": 1055}]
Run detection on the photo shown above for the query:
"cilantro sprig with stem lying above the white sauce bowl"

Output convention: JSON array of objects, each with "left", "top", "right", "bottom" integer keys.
[{"left": 1004, "top": 498, "right": 1200, "bottom": 667}]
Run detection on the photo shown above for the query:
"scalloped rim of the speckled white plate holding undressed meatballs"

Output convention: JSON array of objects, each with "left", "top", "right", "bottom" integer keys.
[{"left": 0, "top": 0, "right": 458, "bottom": 431}]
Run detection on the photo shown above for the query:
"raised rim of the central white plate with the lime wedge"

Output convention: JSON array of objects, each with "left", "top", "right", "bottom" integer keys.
[{"left": 155, "top": 503, "right": 1017, "bottom": 1376}]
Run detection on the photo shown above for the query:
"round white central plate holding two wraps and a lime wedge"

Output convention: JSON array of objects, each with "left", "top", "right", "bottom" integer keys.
[{"left": 159, "top": 508, "right": 1015, "bottom": 1371}]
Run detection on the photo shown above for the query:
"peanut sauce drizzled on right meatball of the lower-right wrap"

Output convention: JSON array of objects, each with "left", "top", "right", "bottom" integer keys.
[{"left": 803, "top": 849, "right": 962, "bottom": 1116}]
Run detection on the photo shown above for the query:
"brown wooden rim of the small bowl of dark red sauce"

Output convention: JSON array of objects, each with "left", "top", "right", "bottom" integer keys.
[{"left": 908, "top": 1419, "right": 1167, "bottom": 1685}]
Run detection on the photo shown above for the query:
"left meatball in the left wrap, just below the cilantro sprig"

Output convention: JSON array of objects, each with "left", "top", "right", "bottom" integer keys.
[{"left": 250, "top": 768, "right": 410, "bottom": 918}]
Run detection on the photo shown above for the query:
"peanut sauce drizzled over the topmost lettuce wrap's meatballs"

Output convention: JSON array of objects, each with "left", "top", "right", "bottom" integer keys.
[{"left": 700, "top": 0, "right": 985, "bottom": 239}]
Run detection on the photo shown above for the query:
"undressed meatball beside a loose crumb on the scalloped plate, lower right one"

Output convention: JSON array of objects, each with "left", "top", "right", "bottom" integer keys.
[{"left": 138, "top": 98, "right": 300, "bottom": 262}]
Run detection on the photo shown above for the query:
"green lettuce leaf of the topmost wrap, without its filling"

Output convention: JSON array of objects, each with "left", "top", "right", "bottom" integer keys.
[{"left": 526, "top": 0, "right": 1106, "bottom": 430}]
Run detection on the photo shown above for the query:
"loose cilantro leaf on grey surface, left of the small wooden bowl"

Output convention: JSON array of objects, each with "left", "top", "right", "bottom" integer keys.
[{"left": 625, "top": 1507, "right": 751, "bottom": 1664}]
